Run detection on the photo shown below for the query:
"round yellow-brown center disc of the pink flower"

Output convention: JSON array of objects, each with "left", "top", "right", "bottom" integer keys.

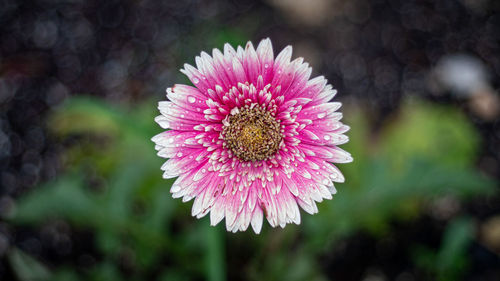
[{"left": 222, "top": 104, "right": 282, "bottom": 161}]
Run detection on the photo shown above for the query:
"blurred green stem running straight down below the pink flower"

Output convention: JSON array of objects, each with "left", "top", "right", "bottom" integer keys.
[{"left": 205, "top": 223, "right": 226, "bottom": 281}]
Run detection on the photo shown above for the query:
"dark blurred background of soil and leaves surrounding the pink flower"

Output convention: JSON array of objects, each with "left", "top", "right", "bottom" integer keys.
[{"left": 0, "top": 0, "right": 500, "bottom": 281}]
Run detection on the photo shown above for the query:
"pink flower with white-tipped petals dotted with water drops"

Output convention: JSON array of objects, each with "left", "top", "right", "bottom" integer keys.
[{"left": 152, "top": 39, "right": 352, "bottom": 233}]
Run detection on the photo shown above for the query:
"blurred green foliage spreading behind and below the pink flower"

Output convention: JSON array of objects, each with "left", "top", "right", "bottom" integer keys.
[{"left": 7, "top": 98, "right": 494, "bottom": 281}]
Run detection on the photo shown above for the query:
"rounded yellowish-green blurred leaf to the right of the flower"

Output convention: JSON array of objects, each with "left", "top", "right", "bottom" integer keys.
[{"left": 379, "top": 100, "right": 479, "bottom": 167}]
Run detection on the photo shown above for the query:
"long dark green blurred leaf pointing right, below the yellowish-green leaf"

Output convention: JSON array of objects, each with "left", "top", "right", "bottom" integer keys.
[{"left": 303, "top": 159, "right": 495, "bottom": 250}]
